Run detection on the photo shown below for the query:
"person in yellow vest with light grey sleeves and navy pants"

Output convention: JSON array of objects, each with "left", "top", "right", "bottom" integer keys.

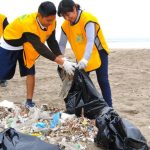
[{"left": 58, "top": 0, "right": 112, "bottom": 107}]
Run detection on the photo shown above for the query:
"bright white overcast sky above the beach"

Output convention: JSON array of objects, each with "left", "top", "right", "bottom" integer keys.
[{"left": 0, "top": 0, "right": 150, "bottom": 47}]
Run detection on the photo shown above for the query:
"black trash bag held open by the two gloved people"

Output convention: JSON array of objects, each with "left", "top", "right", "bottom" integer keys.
[{"left": 58, "top": 68, "right": 108, "bottom": 119}]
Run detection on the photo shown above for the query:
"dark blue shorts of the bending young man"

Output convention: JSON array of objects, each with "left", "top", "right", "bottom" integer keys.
[{"left": 0, "top": 47, "right": 35, "bottom": 80}]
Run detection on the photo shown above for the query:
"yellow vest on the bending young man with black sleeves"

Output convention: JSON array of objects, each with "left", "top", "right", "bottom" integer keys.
[{"left": 4, "top": 13, "right": 56, "bottom": 68}]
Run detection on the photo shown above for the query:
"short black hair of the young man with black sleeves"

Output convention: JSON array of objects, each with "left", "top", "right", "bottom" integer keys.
[{"left": 38, "top": 1, "right": 56, "bottom": 17}]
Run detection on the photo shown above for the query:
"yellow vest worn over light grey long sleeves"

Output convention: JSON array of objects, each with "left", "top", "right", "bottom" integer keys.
[{"left": 62, "top": 12, "right": 109, "bottom": 71}]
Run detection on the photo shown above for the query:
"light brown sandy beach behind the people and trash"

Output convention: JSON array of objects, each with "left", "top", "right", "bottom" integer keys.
[{"left": 0, "top": 49, "right": 150, "bottom": 149}]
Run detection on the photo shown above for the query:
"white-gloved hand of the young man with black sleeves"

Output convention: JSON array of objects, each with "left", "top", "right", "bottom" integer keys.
[{"left": 63, "top": 59, "right": 77, "bottom": 75}]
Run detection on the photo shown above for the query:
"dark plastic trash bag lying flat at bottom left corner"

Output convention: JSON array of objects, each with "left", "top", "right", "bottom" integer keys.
[{"left": 0, "top": 128, "right": 60, "bottom": 150}]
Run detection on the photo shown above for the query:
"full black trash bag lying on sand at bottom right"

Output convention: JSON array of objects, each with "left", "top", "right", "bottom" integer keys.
[{"left": 94, "top": 108, "right": 148, "bottom": 150}]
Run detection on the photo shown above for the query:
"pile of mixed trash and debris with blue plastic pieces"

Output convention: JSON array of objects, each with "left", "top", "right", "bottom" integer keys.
[{"left": 0, "top": 100, "right": 98, "bottom": 149}]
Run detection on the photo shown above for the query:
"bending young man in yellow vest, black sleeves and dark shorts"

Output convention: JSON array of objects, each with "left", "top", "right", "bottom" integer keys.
[{"left": 0, "top": 1, "right": 75, "bottom": 107}]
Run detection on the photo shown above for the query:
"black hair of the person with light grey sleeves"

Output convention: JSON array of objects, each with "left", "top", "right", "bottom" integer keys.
[{"left": 57, "top": 0, "right": 80, "bottom": 17}]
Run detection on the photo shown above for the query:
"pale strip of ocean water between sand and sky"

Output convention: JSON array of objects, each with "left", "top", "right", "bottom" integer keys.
[{"left": 107, "top": 38, "right": 150, "bottom": 49}]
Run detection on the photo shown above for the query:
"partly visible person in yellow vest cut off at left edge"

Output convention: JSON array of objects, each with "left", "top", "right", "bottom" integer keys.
[{"left": 0, "top": 14, "right": 8, "bottom": 87}]
